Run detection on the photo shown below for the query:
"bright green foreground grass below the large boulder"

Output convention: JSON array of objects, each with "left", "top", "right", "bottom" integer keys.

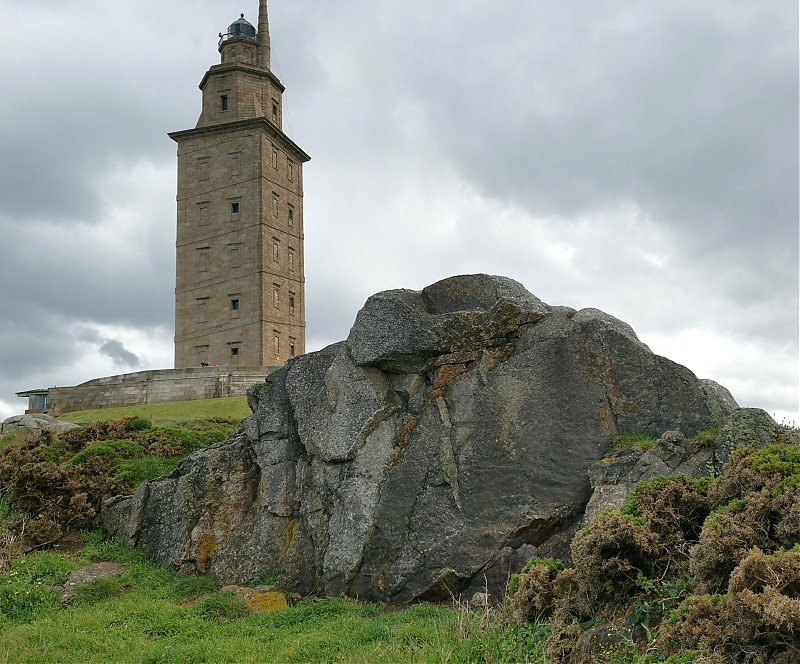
[{"left": 0, "top": 534, "right": 546, "bottom": 664}]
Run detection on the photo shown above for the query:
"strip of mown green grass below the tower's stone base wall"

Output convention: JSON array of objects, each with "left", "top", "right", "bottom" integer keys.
[{"left": 59, "top": 397, "right": 251, "bottom": 424}]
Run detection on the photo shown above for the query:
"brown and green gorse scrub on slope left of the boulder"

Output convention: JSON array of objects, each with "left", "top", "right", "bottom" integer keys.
[{"left": 0, "top": 416, "right": 235, "bottom": 569}]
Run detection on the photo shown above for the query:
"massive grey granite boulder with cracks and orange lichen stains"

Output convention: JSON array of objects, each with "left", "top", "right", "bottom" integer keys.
[{"left": 102, "top": 275, "right": 736, "bottom": 602}]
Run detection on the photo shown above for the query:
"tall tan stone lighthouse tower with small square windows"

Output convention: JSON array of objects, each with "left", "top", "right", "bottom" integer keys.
[{"left": 169, "top": 0, "right": 310, "bottom": 368}]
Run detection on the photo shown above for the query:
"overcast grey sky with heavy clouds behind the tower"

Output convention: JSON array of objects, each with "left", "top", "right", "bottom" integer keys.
[{"left": 0, "top": 0, "right": 800, "bottom": 423}]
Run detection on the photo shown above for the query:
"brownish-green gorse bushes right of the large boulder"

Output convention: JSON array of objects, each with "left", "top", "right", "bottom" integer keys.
[{"left": 510, "top": 441, "right": 800, "bottom": 664}]
